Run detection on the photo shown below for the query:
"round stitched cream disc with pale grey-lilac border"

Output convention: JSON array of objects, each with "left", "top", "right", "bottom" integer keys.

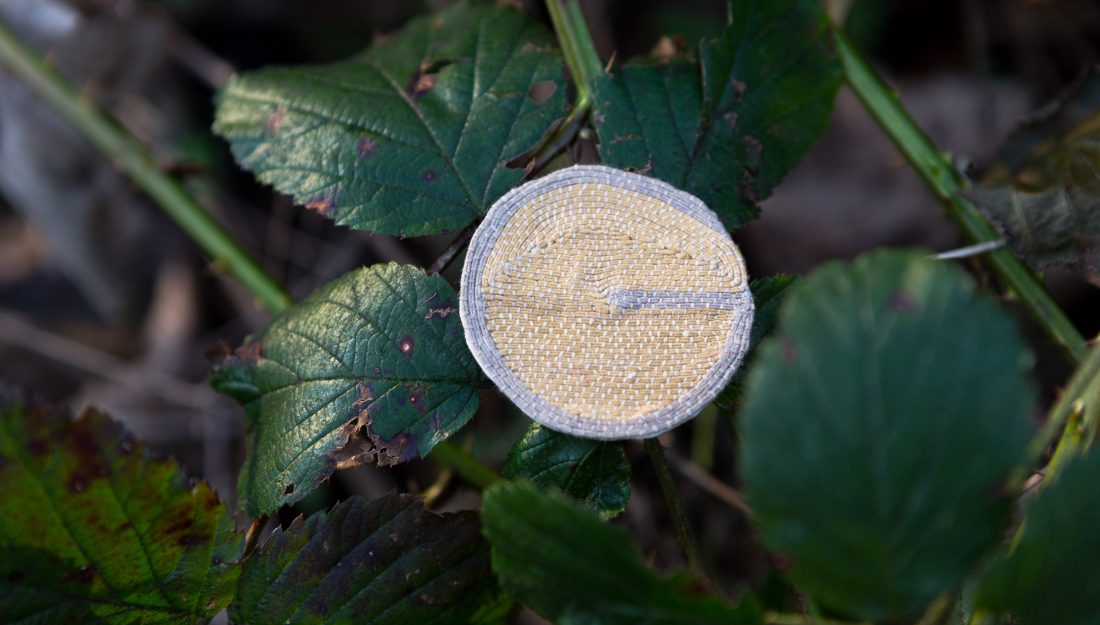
[{"left": 460, "top": 165, "right": 752, "bottom": 439}]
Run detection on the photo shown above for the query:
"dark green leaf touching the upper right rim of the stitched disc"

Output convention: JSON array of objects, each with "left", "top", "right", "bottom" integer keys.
[{"left": 594, "top": 0, "right": 842, "bottom": 230}]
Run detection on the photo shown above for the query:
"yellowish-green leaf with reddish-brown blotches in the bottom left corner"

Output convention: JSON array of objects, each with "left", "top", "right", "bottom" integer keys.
[{"left": 0, "top": 396, "right": 241, "bottom": 624}]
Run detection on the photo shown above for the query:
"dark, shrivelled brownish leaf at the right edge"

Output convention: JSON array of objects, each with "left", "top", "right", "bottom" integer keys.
[{"left": 968, "top": 69, "right": 1100, "bottom": 286}]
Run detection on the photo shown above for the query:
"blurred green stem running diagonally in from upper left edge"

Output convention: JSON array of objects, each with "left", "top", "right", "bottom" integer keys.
[{"left": 0, "top": 23, "right": 290, "bottom": 313}]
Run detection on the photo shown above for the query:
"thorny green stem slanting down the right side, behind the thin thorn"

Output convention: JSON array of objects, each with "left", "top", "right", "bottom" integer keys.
[{"left": 835, "top": 29, "right": 1088, "bottom": 364}]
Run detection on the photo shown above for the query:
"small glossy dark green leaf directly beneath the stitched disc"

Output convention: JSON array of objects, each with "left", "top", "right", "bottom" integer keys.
[{"left": 502, "top": 424, "right": 630, "bottom": 518}]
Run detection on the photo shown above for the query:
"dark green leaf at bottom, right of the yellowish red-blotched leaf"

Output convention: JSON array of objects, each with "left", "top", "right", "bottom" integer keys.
[{"left": 236, "top": 494, "right": 497, "bottom": 625}]
